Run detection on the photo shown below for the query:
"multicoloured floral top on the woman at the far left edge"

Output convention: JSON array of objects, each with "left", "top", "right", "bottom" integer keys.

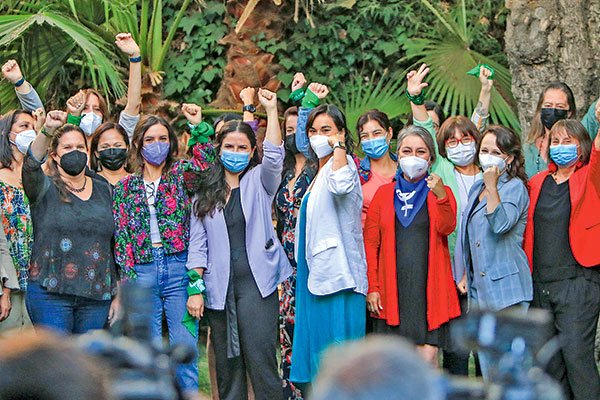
[{"left": 0, "top": 182, "right": 33, "bottom": 290}]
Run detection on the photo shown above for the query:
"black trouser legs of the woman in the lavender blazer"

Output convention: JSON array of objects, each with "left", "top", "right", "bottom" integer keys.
[{"left": 206, "top": 288, "right": 283, "bottom": 400}]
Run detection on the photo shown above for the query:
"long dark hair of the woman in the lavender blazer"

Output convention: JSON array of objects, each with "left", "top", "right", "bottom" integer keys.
[{"left": 194, "top": 120, "right": 260, "bottom": 218}]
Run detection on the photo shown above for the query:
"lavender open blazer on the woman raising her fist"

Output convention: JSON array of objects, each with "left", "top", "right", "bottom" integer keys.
[{"left": 187, "top": 140, "right": 292, "bottom": 310}]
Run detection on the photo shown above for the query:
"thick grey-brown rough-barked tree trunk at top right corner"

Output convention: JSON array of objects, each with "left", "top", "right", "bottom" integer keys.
[{"left": 506, "top": 0, "right": 600, "bottom": 135}]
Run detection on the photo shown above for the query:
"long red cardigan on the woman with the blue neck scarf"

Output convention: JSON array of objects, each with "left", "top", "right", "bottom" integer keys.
[{"left": 364, "top": 182, "right": 460, "bottom": 330}]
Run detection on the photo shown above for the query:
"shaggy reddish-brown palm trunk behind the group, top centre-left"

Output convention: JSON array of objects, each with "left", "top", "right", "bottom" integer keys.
[{"left": 211, "top": 0, "right": 286, "bottom": 108}]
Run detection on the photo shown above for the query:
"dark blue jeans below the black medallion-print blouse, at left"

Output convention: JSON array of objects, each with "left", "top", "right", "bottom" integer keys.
[{"left": 25, "top": 282, "right": 111, "bottom": 334}]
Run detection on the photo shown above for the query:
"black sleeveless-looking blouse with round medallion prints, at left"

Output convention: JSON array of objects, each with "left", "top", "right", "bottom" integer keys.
[{"left": 23, "top": 154, "right": 117, "bottom": 300}]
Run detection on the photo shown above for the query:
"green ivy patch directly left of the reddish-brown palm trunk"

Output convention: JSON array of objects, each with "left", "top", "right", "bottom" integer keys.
[{"left": 164, "top": 0, "right": 229, "bottom": 104}]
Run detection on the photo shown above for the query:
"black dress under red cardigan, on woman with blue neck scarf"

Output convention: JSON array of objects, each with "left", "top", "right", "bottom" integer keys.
[{"left": 375, "top": 204, "right": 446, "bottom": 347}]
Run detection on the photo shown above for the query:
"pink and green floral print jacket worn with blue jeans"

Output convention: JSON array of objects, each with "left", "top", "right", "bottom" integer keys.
[{"left": 113, "top": 143, "right": 214, "bottom": 279}]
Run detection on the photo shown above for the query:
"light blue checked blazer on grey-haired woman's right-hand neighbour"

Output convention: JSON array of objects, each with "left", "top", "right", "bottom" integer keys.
[{"left": 461, "top": 173, "right": 533, "bottom": 311}]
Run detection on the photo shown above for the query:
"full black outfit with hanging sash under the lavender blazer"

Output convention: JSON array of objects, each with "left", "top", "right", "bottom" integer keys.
[{"left": 207, "top": 188, "right": 283, "bottom": 400}]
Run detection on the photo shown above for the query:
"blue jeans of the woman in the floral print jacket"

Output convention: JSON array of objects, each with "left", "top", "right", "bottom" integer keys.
[{"left": 135, "top": 247, "right": 198, "bottom": 392}]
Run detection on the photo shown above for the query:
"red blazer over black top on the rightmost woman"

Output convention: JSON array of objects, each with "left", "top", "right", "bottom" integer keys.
[{"left": 523, "top": 144, "right": 600, "bottom": 270}]
